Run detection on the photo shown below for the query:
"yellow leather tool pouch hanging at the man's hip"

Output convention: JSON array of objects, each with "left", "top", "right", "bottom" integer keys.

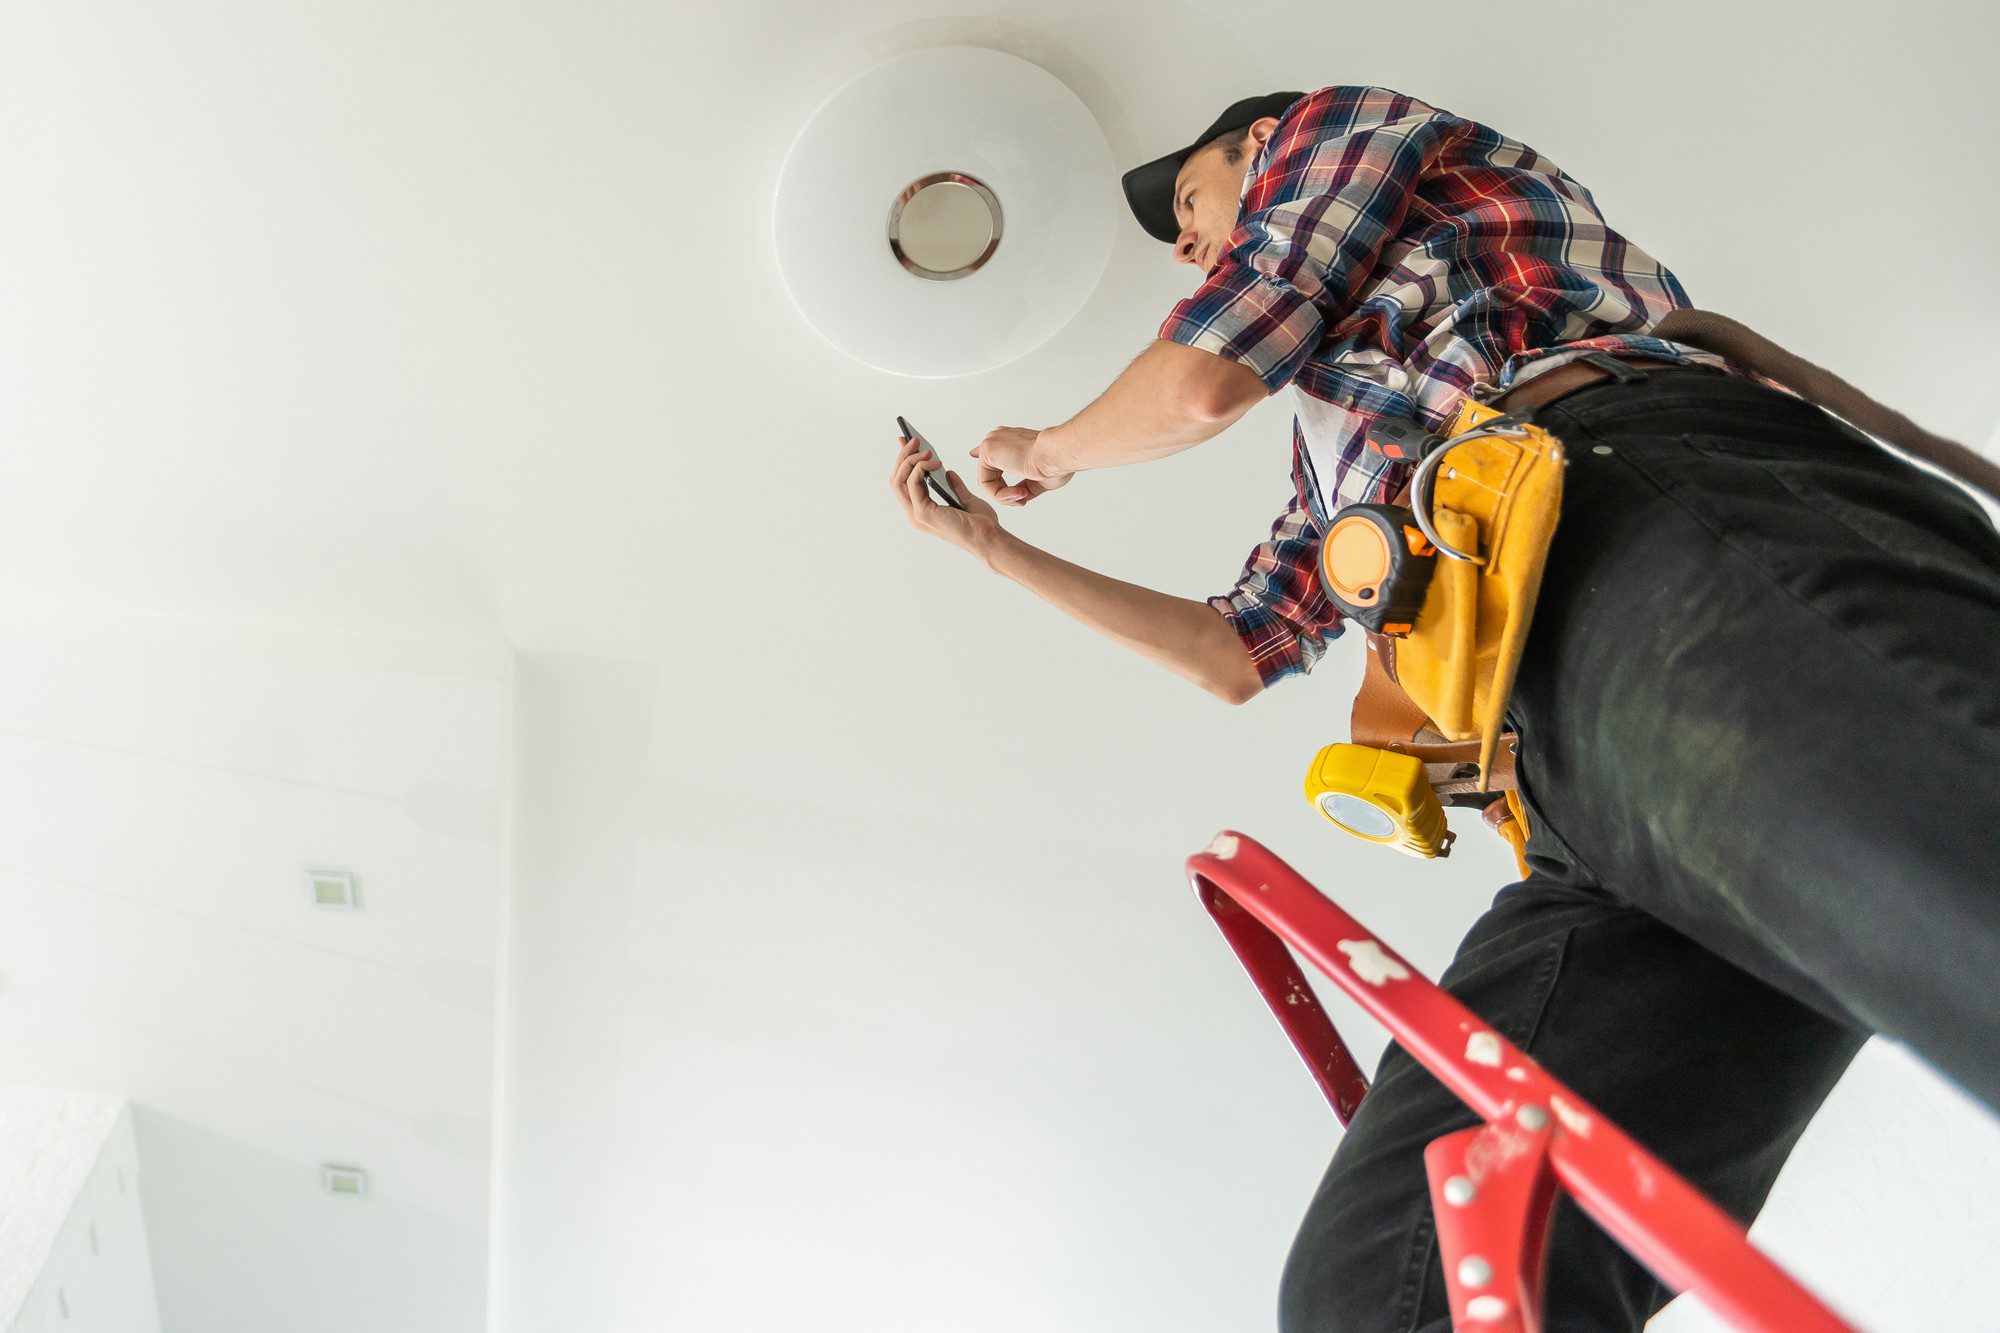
[{"left": 1392, "top": 398, "right": 1564, "bottom": 791}]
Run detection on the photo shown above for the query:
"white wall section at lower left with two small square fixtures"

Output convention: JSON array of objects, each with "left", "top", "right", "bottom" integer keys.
[{"left": 0, "top": 608, "right": 506, "bottom": 1333}]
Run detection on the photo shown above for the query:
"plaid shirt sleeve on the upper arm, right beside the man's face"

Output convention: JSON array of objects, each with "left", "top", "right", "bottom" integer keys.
[{"left": 1160, "top": 88, "right": 1464, "bottom": 392}]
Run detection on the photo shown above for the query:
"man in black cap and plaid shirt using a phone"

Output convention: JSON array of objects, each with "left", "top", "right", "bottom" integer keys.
[{"left": 892, "top": 88, "right": 2000, "bottom": 1333}]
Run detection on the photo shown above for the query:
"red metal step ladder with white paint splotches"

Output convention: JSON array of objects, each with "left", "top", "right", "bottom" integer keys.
[{"left": 1188, "top": 833, "right": 1852, "bottom": 1333}]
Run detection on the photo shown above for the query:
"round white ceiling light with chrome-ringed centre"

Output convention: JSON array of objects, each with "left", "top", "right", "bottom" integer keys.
[{"left": 772, "top": 46, "right": 1122, "bottom": 378}]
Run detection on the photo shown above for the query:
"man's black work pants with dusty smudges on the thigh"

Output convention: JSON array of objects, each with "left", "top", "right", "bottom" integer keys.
[{"left": 1280, "top": 370, "right": 2000, "bottom": 1333}]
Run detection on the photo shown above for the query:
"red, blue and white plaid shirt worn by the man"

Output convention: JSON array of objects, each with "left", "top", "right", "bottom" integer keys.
[{"left": 1160, "top": 88, "right": 1722, "bottom": 685}]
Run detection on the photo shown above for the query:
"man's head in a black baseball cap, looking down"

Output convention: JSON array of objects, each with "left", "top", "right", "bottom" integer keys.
[{"left": 1124, "top": 92, "right": 1306, "bottom": 270}]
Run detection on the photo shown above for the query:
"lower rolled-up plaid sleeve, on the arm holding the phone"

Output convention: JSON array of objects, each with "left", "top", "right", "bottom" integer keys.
[{"left": 1208, "top": 496, "right": 1346, "bottom": 685}]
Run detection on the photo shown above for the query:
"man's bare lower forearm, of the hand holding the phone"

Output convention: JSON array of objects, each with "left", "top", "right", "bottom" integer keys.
[{"left": 978, "top": 530, "right": 1264, "bottom": 703}]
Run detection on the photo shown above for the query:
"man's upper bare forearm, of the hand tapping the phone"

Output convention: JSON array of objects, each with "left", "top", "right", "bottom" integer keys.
[{"left": 1034, "top": 340, "right": 1268, "bottom": 474}]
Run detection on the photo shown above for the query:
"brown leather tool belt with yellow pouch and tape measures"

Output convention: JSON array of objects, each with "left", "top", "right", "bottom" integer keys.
[{"left": 1306, "top": 310, "right": 2000, "bottom": 877}]
